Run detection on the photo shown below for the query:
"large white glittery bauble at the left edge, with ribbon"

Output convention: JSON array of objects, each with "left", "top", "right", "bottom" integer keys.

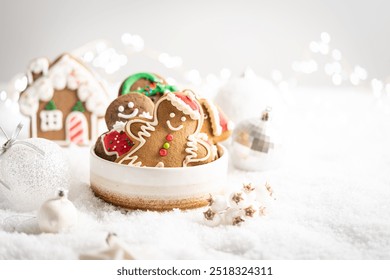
[{"left": 0, "top": 138, "right": 70, "bottom": 211}]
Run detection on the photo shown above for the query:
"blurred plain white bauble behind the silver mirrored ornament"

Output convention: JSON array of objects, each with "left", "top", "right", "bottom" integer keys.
[{"left": 215, "top": 70, "right": 283, "bottom": 124}]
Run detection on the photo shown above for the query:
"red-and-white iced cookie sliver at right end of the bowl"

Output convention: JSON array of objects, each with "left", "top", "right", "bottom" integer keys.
[{"left": 199, "top": 99, "right": 232, "bottom": 144}]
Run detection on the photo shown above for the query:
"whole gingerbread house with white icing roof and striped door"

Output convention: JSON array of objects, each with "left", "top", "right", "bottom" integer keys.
[{"left": 19, "top": 54, "right": 109, "bottom": 146}]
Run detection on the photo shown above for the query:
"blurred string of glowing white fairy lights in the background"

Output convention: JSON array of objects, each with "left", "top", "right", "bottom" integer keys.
[{"left": 0, "top": 32, "right": 390, "bottom": 109}]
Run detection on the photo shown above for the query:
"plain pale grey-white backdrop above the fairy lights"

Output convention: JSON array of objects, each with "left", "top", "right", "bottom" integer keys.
[{"left": 0, "top": 0, "right": 390, "bottom": 81}]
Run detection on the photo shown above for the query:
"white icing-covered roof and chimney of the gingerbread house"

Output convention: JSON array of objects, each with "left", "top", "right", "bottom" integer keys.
[{"left": 19, "top": 54, "right": 109, "bottom": 117}]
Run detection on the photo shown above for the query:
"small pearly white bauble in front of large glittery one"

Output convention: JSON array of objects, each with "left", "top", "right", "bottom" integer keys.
[{"left": 38, "top": 190, "right": 78, "bottom": 233}]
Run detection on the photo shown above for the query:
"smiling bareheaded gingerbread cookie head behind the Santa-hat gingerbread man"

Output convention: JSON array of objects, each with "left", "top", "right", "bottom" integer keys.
[{"left": 105, "top": 93, "right": 154, "bottom": 130}]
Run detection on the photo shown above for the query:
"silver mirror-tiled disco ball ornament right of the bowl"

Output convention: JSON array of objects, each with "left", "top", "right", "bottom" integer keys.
[{"left": 232, "top": 107, "right": 281, "bottom": 171}]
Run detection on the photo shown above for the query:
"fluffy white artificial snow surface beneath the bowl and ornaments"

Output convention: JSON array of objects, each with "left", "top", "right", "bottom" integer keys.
[{"left": 0, "top": 88, "right": 390, "bottom": 259}]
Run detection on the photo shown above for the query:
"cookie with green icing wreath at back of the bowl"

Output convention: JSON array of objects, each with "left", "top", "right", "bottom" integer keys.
[{"left": 119, "top": 72, "right": 177, "bottom": 103}]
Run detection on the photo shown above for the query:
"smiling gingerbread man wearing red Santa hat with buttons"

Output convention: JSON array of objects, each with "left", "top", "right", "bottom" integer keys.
[{"left": 116, "top": 92, "right": 214, "bottom": 167}]
